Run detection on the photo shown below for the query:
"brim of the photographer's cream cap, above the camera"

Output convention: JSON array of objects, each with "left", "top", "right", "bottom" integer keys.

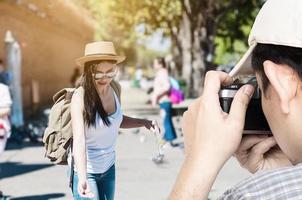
[{"left": 229, "top": 42, "right": 257, "bottom": 77}]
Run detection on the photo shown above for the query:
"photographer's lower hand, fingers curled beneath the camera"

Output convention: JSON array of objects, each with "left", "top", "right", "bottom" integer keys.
[{"left": 235, "top": 135, "right": 292, "bottom": 173}]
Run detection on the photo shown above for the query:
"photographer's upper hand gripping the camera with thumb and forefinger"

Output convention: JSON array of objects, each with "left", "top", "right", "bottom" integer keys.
[{"left": 183, "top": 71, "right": 253, "bottom": 163}]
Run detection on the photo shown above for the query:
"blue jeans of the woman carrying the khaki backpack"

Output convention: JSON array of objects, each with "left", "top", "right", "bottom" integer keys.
[{"left": 73, "top": 165, "right": 115, "bottom": 200}]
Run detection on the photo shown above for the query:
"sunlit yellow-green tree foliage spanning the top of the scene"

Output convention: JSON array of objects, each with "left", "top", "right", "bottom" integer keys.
[{"left": 75, "top": 0, "right": 264, "bottom": 67}]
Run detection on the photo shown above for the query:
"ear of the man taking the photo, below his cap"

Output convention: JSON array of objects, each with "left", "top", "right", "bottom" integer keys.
[{"left": 263, "top": 60, "right": 299, "bottom": 114}]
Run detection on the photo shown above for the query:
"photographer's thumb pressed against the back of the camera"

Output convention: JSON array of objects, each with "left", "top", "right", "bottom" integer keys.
[{"left": 228, "top": 85, "right": 254, "bottom": 125}]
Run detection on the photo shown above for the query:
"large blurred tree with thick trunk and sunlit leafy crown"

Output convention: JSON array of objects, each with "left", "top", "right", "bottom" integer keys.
[{"left": 74, "top": 0, "right": 264, "bottom": 96}]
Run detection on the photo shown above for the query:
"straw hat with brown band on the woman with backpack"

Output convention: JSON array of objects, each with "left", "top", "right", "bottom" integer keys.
[{"left": 76, "top": 41, "right": 126, "bottom": 66}]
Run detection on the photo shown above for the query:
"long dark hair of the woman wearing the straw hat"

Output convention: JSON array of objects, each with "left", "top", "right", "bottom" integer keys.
[{"left": 81, "top": 60, "right": 111, "bottom": 127}]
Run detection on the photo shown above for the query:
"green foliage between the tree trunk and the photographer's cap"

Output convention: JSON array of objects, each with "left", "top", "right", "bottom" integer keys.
[{"left": 215, "top": 0, "right": 264, "bottom": 64}]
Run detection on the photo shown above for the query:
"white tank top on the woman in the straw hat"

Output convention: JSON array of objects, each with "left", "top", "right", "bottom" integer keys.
[{"left": 71, "top": 88, "right": 123, "bottom": 174}]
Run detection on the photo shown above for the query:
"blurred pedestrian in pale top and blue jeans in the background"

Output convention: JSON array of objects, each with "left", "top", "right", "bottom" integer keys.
[{"left": 152, "top": 57, "right": 177, "bottom": 149}]
